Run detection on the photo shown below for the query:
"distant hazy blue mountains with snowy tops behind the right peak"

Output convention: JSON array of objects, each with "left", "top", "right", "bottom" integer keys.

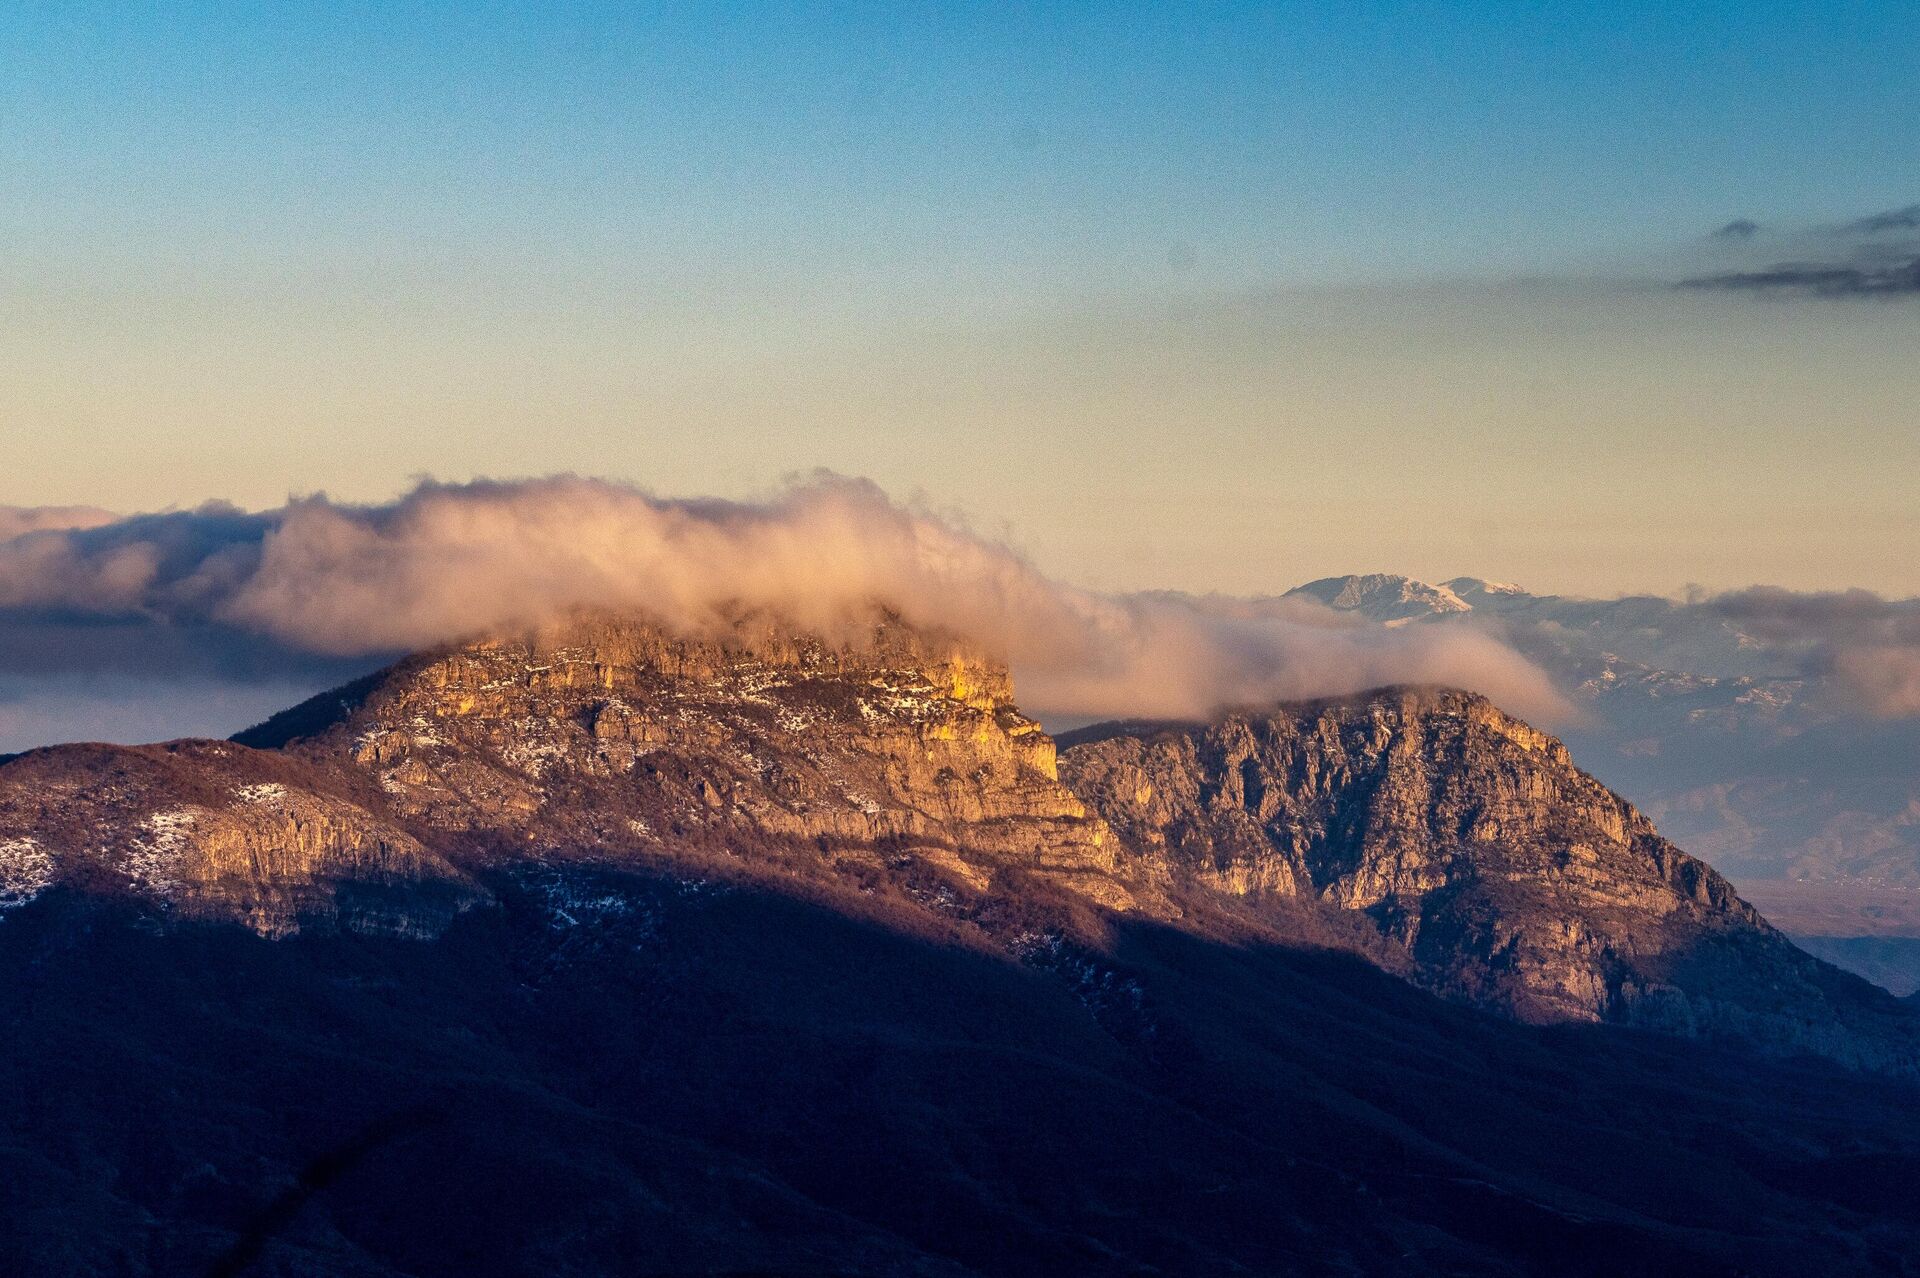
[{"left": 1290, "top": 574, "right": 1920, "bottom": 905}]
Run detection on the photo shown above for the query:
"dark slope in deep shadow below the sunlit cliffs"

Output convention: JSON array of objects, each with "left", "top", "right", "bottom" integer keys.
[{"left": 11, "top": 865, "right": 1920, "bottom": 1276}]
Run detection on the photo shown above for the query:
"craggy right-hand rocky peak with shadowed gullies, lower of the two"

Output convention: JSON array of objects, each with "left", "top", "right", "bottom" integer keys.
[{"left": 1062, "top": 689, "right": 1912, "bottom": 1057}]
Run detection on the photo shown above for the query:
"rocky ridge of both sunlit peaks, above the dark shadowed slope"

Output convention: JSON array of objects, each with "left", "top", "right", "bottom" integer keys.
[{"left": 0, "top": 616, "right": 1920, "bottom": 1071}]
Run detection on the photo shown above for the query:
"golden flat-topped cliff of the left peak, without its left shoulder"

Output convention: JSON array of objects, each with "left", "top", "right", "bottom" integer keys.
[{"left": 263, "top": 618, "right": 1123, "bottom": 890}]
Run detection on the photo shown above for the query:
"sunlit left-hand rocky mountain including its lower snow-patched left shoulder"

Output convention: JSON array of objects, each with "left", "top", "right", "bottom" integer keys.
[{"left": 0, "top": 618, "right": 1135, "bottom": 935}]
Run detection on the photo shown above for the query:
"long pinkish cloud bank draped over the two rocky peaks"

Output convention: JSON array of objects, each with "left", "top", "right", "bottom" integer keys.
[{"left": 0, "top": 474, "right": 1567, "bottom": 736}]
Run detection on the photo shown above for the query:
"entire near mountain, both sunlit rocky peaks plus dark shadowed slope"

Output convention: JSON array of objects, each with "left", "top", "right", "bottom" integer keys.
[{"left": 0, "top": 618, "right": 1920, "bottom": 1274}]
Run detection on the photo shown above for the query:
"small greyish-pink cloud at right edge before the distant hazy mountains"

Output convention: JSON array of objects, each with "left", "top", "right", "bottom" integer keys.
[{"left": 1705, "top": 585, "right": 1920, "bottom": 718}]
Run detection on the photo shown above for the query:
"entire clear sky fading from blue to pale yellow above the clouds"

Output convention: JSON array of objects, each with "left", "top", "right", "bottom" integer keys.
[{"left": 0, "top": 4, "right": 1920, "bottom": 591}]
